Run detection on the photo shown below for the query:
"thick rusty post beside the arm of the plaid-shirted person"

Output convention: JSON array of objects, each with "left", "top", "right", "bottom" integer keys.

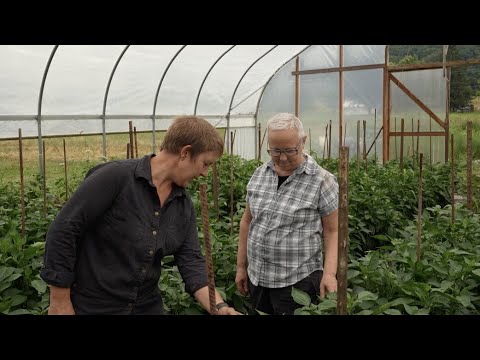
[{"left": 337, "top": 146, "right": 349, "bottom": 315}]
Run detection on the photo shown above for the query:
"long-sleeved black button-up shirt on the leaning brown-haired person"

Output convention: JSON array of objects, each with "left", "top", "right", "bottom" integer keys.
[{"left": 41, "top": 155, "right": 208, "bottom": 314}]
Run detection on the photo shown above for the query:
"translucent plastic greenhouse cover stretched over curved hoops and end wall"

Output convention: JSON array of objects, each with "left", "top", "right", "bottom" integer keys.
[{"left": 5, "top": 45, "right": 446, "bottom": 159}]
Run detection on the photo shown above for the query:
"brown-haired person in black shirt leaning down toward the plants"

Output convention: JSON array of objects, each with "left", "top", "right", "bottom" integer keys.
[{"left": 41, "top": 116, "right": 238, "bottom": 315}]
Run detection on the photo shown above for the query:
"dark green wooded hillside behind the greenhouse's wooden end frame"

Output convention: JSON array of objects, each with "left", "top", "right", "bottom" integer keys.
[{"left": 389, "top": 45, "right": 480, "bottom": 111}]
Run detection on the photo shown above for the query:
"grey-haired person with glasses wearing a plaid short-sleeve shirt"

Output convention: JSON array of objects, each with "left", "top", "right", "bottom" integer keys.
[{"left": 235, "top": 113, "right": 338, "bottom": 315}]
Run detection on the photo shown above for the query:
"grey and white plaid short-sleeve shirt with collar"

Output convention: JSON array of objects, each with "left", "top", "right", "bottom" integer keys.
[{"left": 246, "top": 154, "right": 338, "bottom": 288}]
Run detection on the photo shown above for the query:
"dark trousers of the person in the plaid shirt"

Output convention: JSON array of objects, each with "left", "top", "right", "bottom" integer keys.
[{"left": 248, "top": 270, "right": 323, "bottom": 315}]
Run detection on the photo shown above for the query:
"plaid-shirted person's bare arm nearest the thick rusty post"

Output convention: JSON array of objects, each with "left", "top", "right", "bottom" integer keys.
[{"left": 320, "top": 210, "right": 338, "bottom": 298}]
